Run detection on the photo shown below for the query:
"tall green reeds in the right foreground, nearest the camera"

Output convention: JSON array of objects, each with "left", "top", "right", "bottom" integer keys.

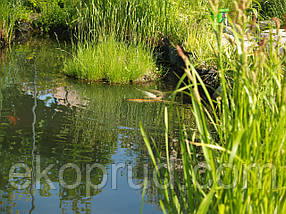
[{"left": 142, "top": 0, "right": 286, "bottom": 213}]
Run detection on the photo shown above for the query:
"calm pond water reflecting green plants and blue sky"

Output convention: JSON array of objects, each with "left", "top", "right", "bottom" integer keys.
[{"left": 0, "top": 40, "right": 188, "bottom": 213}]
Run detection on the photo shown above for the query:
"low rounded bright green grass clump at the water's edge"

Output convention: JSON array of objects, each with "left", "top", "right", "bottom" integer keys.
[{"left": 64, "top": 36, "right": 159, "bottom": 83}]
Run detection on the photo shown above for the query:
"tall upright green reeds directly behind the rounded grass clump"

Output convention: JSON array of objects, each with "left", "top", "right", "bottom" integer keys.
[{"left": 77, "top": 0, "right": 203, "bottom": 45}]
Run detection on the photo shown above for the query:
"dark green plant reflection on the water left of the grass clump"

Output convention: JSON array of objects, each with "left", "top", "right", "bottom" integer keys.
[{"left": 3, "top": 38, "right": 68, "bottom": 90}]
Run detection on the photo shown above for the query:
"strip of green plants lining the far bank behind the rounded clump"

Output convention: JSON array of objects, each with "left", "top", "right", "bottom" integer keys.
[{"left": 0, "top": 0, "right": 286, "bottom": 71}]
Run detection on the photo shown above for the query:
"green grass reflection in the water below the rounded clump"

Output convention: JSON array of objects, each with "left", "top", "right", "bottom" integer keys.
[{"left": 49, "top": 84, "right": 169, "bottom": 163}]
